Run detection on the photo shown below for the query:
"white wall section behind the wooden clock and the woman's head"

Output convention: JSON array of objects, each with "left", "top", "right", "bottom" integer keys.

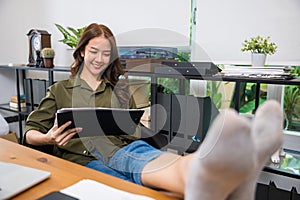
[{"left": 0, "top": 0, "right": 190, "bottom": 66}]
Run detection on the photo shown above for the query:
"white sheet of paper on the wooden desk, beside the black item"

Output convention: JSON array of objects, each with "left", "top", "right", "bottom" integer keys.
[{"left": 60, "top": 179, "right": 153, "bottom": 200}]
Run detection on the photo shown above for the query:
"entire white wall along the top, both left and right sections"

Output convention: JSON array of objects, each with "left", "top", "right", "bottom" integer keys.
[{"left": 0, "top": 0, "right": 300, "bottom": 66}]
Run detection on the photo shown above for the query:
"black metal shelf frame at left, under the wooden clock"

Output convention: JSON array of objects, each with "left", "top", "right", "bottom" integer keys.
[{"left": 0, "top": 65, "right": 70, "bottom": 142}]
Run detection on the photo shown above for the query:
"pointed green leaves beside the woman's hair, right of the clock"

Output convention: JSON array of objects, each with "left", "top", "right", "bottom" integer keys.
[{"left": 55, "top": 24, "right": 86, "bottom": 48}]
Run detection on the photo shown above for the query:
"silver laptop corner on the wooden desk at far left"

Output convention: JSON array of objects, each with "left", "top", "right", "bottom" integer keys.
[{"left": 0, "top": 161, "right": 51, "bottom": 199}]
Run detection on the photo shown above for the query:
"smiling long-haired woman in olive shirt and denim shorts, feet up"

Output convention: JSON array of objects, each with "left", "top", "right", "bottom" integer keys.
[{"left": 24, "top": 23, "right": 281, "bottom": 199}]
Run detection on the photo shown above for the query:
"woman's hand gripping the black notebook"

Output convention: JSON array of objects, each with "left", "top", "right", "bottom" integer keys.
[{"left": 47, "top": 120, "right": 82, "bottom": 146}]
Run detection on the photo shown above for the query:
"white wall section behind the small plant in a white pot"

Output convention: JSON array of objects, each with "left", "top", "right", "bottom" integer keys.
[{"left": 194, "top": 0, "right": 300, "bottom": 65}]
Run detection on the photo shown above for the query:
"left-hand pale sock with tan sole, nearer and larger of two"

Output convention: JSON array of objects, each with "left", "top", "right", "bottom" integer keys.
[{"left": 185, "top": 110, "right": 255, "bottom": 200}]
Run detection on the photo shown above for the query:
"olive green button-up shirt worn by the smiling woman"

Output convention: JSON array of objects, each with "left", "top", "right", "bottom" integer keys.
[{"left": 24, "top": 76, "right": 140, "bottom": 165}]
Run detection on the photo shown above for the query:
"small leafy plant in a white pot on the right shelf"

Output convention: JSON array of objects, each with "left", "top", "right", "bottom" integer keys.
[{"left": 241, "top": 35, "right": 277, "bottom": 66}]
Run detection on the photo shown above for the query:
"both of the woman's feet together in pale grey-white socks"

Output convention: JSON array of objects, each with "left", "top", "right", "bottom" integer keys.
[{"left": 185, "top": 101, "right": 283, "bottom": 200}]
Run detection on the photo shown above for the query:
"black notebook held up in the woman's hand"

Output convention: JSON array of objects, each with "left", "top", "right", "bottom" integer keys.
[{"left": 56, "top": 107, "right": 144, "bottom": 137}]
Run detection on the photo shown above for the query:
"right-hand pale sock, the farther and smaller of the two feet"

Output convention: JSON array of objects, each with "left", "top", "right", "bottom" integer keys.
[{"left": 227, "top": 100, "right": 283, "bottom": 200}]
